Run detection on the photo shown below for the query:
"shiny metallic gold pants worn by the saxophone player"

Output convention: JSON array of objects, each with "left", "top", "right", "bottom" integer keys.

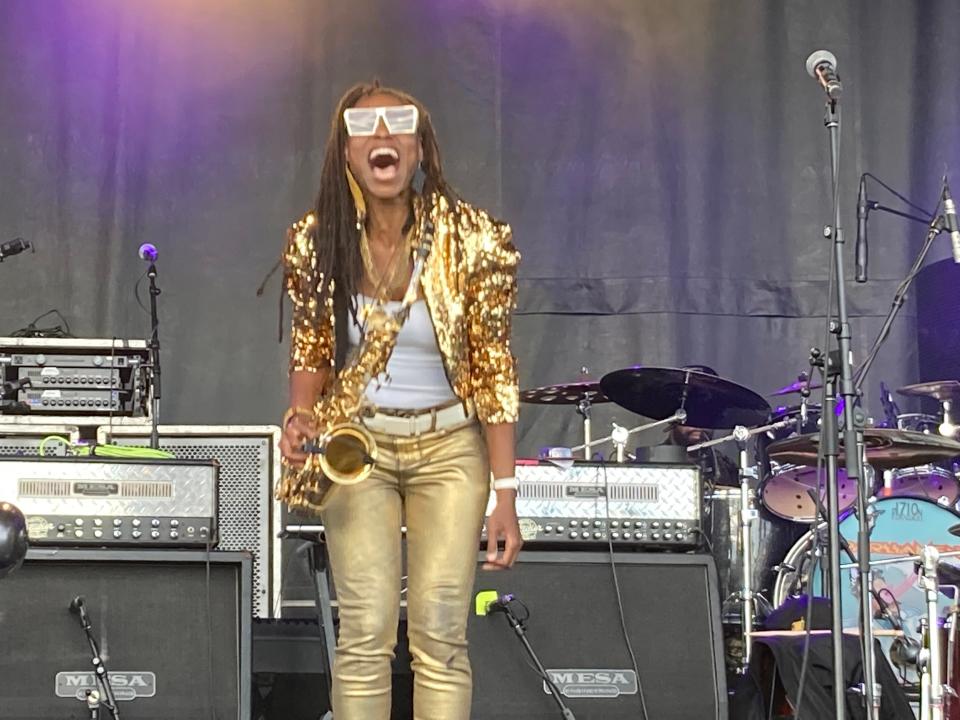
[{"left": 323, "top": 419, "right": 490, "bottom": 720}]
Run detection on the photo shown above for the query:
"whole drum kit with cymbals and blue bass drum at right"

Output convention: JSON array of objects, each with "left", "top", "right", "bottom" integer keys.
[{"left": 521, "top": 366, "right": 960, "bottom": 704}]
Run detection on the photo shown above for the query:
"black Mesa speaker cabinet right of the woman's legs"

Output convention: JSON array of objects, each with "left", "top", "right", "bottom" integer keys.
[{"left": 468, "top": 552, "right": 727, "bottom": 720}]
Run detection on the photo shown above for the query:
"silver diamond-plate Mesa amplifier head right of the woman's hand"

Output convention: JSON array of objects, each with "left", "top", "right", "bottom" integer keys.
[{"left": 487, "top": 462, "right": 702, "bottom": 549}]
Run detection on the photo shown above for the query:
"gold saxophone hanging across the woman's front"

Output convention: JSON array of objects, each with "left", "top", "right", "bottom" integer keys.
[{"left": 276, "top": 220, "right": 433, "bottom": 512}]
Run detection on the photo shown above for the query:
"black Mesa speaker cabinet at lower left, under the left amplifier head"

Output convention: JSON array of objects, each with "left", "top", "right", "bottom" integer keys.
[{"left": 0, "top": 549, "right": 251, "bottom": 720}]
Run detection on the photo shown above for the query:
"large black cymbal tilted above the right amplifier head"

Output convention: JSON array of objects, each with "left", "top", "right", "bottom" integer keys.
[{"left": 600, "top": 366, "right": 770, "bottom": 430}]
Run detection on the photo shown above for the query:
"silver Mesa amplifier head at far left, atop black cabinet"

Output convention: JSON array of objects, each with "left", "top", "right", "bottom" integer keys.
[{"left": 0, "top": 457, "right": 219, "bottom": 547}]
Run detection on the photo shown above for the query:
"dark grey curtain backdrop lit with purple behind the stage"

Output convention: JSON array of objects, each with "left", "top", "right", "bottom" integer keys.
[{"left": 0, "top": 0, "right": 960, "bottom": 455}]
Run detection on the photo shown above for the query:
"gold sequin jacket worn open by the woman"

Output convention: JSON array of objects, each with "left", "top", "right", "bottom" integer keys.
[{"left": 284, "top": 195, "right": 520, "bottom": 423}]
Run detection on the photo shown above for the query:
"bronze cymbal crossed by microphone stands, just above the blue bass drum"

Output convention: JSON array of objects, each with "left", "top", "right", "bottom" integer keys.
[{"left": 767, "top": 428, "right": 960, "bottom": 470}]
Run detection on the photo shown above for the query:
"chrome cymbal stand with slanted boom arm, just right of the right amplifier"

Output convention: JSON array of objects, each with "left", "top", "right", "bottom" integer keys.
[{"left": 687, "top": 418, "right": 794, "bottom": 675}]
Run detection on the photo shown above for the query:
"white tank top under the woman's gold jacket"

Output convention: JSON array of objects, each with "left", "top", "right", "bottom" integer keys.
[{"left": 347, "top": 293, "right": 457, "bottom": 410}]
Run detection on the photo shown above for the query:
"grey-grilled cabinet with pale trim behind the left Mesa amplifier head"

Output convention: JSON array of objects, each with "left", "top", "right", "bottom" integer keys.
[{"left": 97, "top": 425, "right": 281, "bottom": 618}]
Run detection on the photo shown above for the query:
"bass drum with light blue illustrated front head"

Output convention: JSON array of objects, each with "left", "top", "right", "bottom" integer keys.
[{"left": 773, "top": 498, "right": 960, "bottom": 682}]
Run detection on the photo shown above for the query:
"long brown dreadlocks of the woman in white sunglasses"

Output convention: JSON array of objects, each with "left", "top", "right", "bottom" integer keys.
[{"left": 314, "top": 80, "right": 457, "bottom": 307}]
